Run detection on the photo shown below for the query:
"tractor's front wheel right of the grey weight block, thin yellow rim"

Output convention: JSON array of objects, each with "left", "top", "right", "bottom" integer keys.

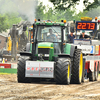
[{"left": 55, "top": 58, "right": 71, "bottom": 84}]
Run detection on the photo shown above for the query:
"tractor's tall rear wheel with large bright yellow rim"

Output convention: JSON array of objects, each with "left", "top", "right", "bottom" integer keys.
[{"left": 71, "top": 49, "right": 83, "bottom": 84}]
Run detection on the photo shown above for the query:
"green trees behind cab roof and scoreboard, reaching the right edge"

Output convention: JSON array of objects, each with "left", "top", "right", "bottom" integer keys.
[{"left": 36, "top": 0, "right": 100, "bottom": 22}]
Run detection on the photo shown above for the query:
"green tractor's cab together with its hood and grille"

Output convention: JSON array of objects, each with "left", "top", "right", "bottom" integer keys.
[{"left": 32, "top": 20, "right": 66, "bottom": 61}]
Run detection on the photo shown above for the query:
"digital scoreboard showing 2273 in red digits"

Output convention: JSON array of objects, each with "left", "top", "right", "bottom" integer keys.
[{"left": 76, "top": 21, "right": 97, "bottom": 30}]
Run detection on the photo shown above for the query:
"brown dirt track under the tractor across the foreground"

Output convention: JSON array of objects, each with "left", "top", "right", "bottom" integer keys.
[{"left": 0, "top": 74, "right": 100, "bottom": 100}]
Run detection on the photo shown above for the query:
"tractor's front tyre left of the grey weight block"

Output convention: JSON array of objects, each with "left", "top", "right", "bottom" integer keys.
[{"left": 17, "top": 57, "right": 31, "bottom": 83}]
